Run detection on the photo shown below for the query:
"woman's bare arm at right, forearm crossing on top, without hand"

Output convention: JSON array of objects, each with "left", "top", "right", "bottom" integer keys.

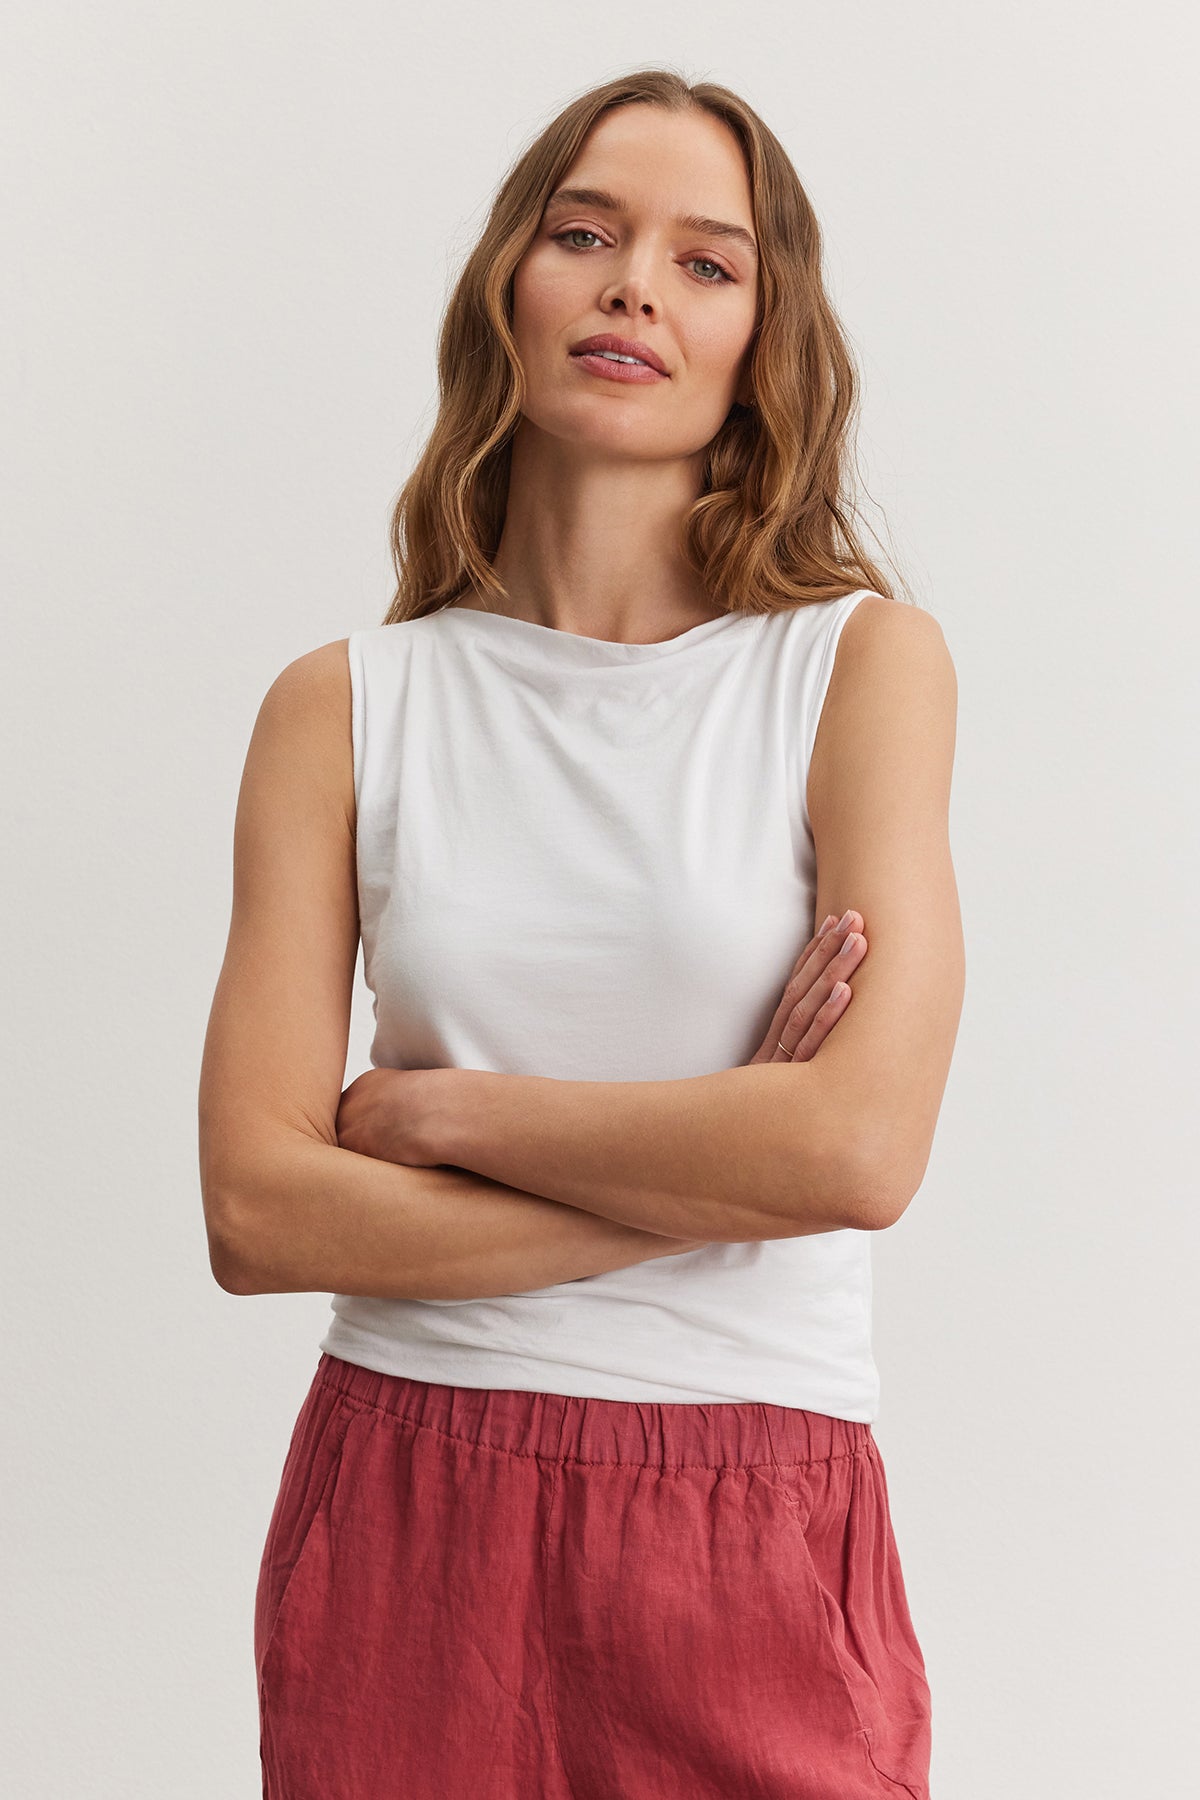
[{"left": 352, "top": 596, "right": 964, "bottom": 1242}]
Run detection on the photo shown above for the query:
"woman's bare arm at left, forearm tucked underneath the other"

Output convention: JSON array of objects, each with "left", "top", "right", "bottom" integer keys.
[{"left": 200, "top": 639, "right": 705, "bottom": 1300}]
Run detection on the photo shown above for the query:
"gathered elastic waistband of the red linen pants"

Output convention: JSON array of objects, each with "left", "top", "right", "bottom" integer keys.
[{"left": 315, "top": 1350, "right": 874, "bottom": 1469}]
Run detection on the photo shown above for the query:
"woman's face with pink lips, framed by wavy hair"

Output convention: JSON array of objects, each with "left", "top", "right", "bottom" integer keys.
[{"left": 513, "top": 103, "right": 757, "bottom": 461}]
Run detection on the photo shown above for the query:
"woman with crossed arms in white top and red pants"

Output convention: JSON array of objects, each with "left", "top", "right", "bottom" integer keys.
[{"left": 201, "top": 70, "right": 963, "bottom": 1800}]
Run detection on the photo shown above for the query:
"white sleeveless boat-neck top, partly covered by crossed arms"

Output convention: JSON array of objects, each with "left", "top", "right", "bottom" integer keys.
[{"left": 320, "top": 589, "right": 878, "bottom": 1422}]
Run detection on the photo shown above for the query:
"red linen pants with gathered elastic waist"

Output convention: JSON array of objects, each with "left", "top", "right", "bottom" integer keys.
[{"left": 254, "top": 1352, "right": 930, "bottom": 1800}]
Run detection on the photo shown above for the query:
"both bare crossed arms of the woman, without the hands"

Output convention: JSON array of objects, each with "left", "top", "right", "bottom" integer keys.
[{"left": 200, "top": 598, "right": 964, "bottom": 1298}]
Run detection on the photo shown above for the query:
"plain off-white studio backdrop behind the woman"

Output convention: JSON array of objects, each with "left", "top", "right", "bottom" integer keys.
[{"left": 0, "top": 0, "right": 1200, "bottom": 1800}]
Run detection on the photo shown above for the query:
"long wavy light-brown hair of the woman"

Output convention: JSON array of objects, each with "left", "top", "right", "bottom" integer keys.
[{"left": 383, "top": 68, "right": 909, "bottom": 625}]
